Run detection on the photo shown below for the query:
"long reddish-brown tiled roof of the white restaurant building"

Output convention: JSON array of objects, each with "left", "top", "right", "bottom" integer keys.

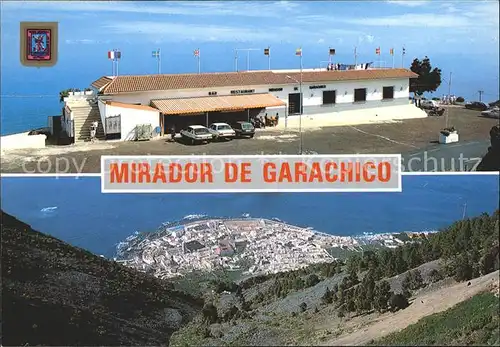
[{"left": 92, "top": 69, "right": 418, "bottom": 94}]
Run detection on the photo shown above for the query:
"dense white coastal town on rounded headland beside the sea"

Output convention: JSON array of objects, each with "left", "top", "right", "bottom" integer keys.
[{"left": 115, "top": 218, "right": 420, "bottom": 278}]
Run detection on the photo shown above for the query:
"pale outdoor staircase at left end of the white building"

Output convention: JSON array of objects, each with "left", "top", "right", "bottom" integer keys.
[{"left": 70, "top": 100, "right": 106, "bottom": 143}]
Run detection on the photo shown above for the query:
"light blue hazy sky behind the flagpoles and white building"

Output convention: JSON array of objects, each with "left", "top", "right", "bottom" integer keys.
[{"left": 0, "top": 0, "right": 499, "bottom": 133}]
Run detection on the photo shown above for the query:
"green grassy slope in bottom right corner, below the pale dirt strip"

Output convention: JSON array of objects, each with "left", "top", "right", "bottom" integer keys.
[{"left": 372, "top": 293, "right": 500, "bottom": 346}]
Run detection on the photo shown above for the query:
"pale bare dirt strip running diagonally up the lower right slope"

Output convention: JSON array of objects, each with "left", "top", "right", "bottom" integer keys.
[{"left": 322, "top": 271, "right": 499, "bottom": 346}]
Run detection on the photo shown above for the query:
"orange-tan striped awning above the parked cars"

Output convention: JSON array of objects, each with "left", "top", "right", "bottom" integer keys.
[{"left": 151, "top": 94, "right": 286, "bottom": 115}]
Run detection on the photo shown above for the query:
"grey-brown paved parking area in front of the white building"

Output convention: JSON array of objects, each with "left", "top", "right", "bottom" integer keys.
[{"left": 2, "top": 108, "right": 498, "bottom": 173}]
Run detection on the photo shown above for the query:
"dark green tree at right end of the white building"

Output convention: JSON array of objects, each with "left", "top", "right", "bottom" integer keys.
[{"left": 410, "top": 56, "right": 441, "bottom": 96}]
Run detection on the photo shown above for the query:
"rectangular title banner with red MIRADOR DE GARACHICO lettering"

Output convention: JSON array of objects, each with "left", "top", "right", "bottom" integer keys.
[{"left": 101, "top": 154, "right": 402, "bottom": 193}]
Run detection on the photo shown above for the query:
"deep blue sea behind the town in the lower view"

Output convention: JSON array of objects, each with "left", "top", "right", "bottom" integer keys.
[{"left": 1, "top": 175, "right": 499, "bottom": 257}]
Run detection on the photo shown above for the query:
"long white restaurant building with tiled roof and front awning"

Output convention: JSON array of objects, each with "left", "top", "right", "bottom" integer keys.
[{"left": 60, "top": 69, "right": 422, "bottom": 140}]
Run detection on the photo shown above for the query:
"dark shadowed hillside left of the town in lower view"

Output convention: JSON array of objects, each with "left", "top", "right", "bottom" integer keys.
[{"left": 1, "top": 211, "right": 203, "bottom": 346}]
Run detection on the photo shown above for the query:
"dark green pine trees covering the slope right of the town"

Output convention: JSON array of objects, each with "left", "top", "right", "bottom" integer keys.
[{"left": 186, "top": 211, "right": 500, "bottom": 334}]
